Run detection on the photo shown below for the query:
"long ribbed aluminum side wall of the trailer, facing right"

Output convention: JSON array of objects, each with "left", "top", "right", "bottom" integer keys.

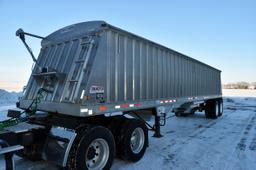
[{"left": 102, "top": 29, "right": 221, "bottom": 102}]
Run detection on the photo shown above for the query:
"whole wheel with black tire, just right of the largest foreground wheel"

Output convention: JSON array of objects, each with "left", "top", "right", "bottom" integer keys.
[{"left": 118, "top": 119, "right": 148, "bottom": 162}]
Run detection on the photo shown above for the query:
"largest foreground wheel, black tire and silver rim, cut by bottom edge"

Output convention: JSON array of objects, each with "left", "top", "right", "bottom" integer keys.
[{"left": 67, "top": 126, "right": 115, "bottom": 170}]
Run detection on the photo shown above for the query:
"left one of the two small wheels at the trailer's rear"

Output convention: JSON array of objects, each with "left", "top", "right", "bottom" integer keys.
[{"left": 205, "top": 100, "right": 219, "bottom": 119}]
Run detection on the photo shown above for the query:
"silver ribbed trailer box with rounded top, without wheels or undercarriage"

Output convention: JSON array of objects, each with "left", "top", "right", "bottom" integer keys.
[{"left": 20, "top": 21, "right": 221, "bottom": 117}]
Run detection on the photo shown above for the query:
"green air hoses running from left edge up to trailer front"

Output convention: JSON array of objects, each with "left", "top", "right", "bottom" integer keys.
[{"left": 0, "top": 88, "right": 50, "bottom": 131}]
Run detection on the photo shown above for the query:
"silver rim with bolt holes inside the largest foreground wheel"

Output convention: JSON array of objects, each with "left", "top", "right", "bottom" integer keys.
[{"left": 85, "top": 138, "right": 109, "bottom": 170}]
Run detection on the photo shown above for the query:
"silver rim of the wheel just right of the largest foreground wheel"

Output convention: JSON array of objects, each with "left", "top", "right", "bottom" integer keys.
[{"left": 130, "top": 127, "right": 145, "bottom": 154}]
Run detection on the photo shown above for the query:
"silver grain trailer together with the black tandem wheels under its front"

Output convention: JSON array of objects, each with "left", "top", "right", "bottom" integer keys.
[{"left": 0, "top": 21, "right": 222, "bottom": 169}]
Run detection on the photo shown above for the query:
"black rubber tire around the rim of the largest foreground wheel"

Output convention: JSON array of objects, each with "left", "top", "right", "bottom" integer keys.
[{"left": 75, "top": 126, "right": 115, "bottom": 170}]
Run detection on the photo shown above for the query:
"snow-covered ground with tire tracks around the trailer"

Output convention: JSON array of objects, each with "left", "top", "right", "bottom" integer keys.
[{"left": 0, "top": 90, "right": 256, "bottom": 170}]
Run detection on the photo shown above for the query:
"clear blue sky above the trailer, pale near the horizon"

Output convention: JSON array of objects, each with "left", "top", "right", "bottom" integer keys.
[{"left": 0, "top": 0, "right": 256, "bottom": 90}]
